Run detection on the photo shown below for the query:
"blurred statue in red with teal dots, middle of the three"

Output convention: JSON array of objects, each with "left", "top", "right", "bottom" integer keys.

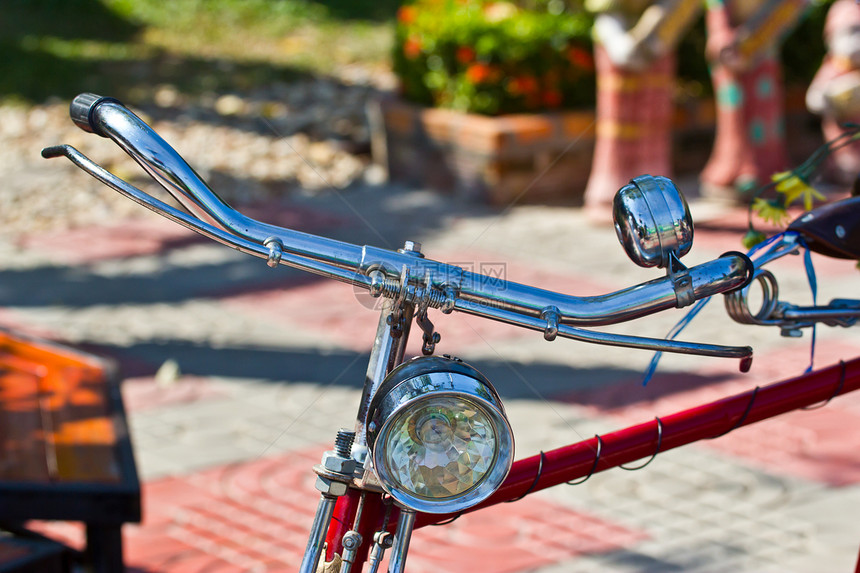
[{"left": 700, "top": 0, "right": 808, "bottom": 201}]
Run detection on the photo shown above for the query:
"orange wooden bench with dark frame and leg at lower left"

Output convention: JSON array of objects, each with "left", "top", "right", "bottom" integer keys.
[{"left": 0, "top": 329, "right": 141, "bottom": 572}]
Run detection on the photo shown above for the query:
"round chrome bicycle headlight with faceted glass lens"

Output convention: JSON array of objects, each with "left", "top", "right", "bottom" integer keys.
[{"left": 367, "top": 356, "right": 514, "bottom": 513}]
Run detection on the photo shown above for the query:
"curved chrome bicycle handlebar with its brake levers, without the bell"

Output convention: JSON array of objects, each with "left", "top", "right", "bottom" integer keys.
[{"left": 42, "top": 94, "right": 752, "bottom": 362}]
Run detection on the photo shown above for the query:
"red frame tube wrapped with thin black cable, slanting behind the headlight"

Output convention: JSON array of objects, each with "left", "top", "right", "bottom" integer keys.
[{"left": 415, "top": 358, "right": 860, "bottom": 527}]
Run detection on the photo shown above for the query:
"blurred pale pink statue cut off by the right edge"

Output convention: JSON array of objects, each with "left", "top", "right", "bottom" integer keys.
[{"left": 806, "top": 0, "right": 860, "bottom": 183}]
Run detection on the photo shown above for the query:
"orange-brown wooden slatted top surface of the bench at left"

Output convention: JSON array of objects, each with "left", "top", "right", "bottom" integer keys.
[{"left": 0, "top": 332, "right": 122, "bottom": 483}]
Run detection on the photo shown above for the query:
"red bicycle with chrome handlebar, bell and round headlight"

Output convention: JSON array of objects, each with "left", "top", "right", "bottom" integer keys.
[{"left": 43, "top": 94, "right": 860, "bottom": 573}]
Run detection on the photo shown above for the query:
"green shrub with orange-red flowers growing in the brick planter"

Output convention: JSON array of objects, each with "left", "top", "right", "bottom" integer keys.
[{"left": 394, "top": 0, "right": 594, "bottom": 115}]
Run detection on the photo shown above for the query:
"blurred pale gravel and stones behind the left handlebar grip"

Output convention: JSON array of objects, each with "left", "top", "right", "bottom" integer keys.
[{"left": 0, "top": 77, "right": 390, "bottom": 236}]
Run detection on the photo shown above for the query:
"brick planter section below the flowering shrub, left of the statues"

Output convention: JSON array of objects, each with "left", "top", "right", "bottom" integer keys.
[{"left": 370, "top": 99, "right": 594, "bottom": 205}]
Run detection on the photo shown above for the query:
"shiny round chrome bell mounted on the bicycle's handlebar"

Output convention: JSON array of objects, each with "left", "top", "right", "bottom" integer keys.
[{"left": 612, "top": 175, "right": 693, "bottom": 268}]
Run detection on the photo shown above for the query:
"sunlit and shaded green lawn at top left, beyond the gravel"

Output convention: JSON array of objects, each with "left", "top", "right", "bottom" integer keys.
[{"left": 0, "top": 0, "right": 401, "bottom": 103}]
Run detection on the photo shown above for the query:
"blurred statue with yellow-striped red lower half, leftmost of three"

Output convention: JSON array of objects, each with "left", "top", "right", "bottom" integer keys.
[{"left": 585, "top": 0, "right": 701, "bottom": 223}]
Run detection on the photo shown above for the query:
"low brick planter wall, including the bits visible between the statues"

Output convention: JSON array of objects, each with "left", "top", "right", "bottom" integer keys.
[{"left": 369, "top": 94, "right": 820, "bottom": 206}]
